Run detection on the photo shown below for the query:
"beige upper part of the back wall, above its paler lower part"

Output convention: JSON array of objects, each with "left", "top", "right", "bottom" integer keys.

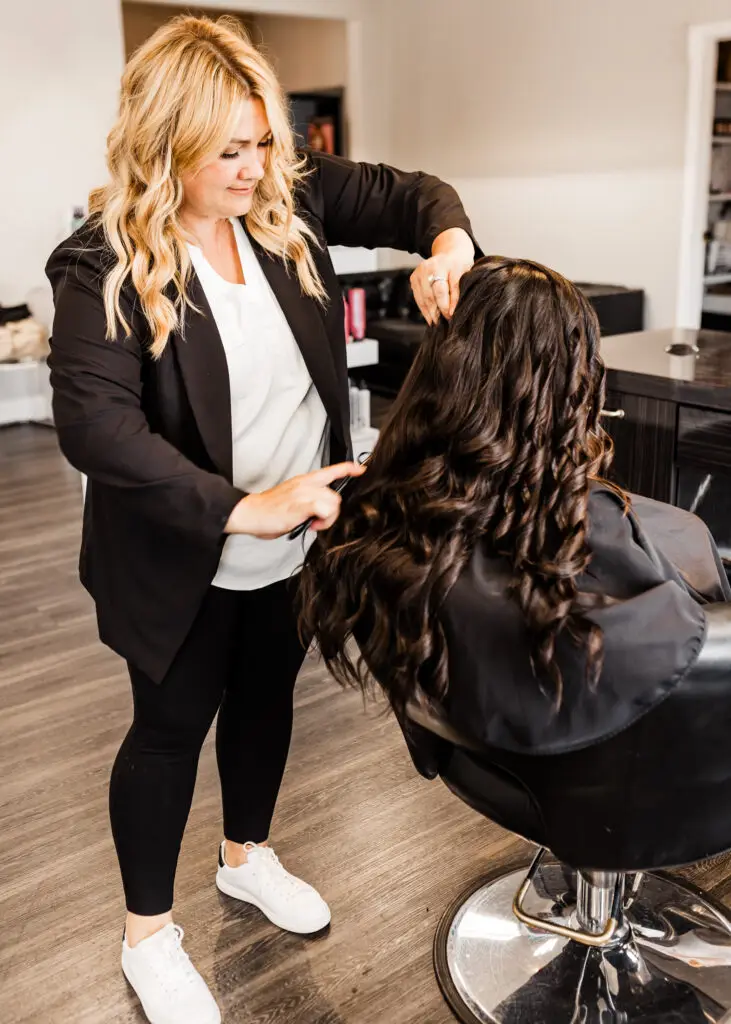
[{"left": 391, "top": 0, "right": 731, "bottom": 177}]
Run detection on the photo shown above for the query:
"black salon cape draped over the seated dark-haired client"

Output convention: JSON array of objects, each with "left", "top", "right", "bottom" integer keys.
[{"left": 436, "top": 484, "right": 731, "bottom": 763}]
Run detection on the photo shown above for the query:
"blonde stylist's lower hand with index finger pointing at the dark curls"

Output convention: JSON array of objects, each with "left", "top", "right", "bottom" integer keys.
[{"left": 225, "top": 462, "right": 366, "bottom": 541}]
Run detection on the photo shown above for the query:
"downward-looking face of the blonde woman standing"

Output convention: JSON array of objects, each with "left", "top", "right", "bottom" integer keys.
[{"left": 181, "top": 99, "right": 271, "bottom": 218}]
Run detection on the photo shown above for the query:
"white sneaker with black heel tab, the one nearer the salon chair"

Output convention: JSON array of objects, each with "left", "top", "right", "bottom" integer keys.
[{"left": 216, "top": 843, "right": 330, "bottom": 935}]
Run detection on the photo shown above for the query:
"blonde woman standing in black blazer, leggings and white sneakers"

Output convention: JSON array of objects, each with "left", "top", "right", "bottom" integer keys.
[{"left": 47, "top": 9, "right": 474, "bottom": 1024}]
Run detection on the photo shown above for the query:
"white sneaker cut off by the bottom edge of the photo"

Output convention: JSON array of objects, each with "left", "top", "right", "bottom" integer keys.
[{"left": 122, "top": 924, "right": 221, "bottom": 1024}]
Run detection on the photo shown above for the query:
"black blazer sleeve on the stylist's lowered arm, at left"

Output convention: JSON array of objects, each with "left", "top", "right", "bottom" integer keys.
[{"left": 46, "top": 243, "right": 245, "bottom": 543}]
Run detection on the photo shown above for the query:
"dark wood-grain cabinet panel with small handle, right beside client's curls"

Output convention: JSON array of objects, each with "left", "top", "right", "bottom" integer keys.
[{"left": 602, "top": 391, "right": 677, "bottom": 502}]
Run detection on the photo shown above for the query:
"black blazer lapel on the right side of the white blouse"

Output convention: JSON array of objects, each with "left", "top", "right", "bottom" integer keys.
[{"left": 245, "top": 225, "right": 347, "bottom": 446}]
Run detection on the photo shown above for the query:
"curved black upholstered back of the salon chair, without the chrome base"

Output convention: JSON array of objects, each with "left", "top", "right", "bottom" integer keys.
[{"left": 409, "top": 604, "right": 731, "bottom": 871}]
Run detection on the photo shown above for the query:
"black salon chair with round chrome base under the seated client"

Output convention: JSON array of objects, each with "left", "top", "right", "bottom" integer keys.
[{"left": 404, "top": 493, "right": 731, "bottom": 1024}]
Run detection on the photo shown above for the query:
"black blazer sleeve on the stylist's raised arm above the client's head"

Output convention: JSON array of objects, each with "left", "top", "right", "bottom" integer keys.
[{"left": 298, "top": 153, "right": 483, "bottom": 258}]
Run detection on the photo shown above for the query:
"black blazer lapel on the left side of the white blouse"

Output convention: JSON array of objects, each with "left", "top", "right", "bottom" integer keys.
[{"left": 175, "top": 270, "right": 233, "bottom": 481}]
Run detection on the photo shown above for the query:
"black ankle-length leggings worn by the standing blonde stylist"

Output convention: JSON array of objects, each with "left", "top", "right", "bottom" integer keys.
[{"left": 110, "top": 583, "right": 305, "bottom": 914}]
